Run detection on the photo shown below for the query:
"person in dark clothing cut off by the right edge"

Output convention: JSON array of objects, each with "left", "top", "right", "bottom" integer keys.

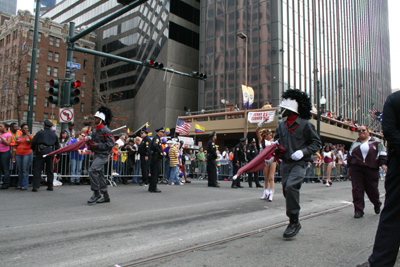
[{"left": 369, "top": 91, "right": 400, "bottom": 267}]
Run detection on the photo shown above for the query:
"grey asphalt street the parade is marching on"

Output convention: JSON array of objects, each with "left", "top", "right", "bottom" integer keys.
[{"left": 0, "top": 180, "right": 400, "bottom": 266}]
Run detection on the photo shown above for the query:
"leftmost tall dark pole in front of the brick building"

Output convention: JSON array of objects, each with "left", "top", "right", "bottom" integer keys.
[{"left": 27, "top": 0, "right": 40, "bottom": 132}]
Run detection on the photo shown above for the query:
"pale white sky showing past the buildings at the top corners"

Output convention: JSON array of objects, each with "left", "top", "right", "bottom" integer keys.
[{"left": 17, "top": 0, "right": 400, "bottom": 89}]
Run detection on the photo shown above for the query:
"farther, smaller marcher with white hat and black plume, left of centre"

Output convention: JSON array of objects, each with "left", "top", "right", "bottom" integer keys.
[{"left": 85, "top": 107, "right": 115, "bottom": 203}]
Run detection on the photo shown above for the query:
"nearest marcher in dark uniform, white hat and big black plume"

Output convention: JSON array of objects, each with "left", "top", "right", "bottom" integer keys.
[{"left": 274, "top": 89, "right": 321, "bottom": 238}]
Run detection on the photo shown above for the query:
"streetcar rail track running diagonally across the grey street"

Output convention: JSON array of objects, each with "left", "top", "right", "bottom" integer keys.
[{"left": 115, "top": 202, "right": 353, "bottom": 267}]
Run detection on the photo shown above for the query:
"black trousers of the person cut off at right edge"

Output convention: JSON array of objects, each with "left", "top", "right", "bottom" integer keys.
[{"left": 368, "top": 157, "right": 400, "bottom": 267}]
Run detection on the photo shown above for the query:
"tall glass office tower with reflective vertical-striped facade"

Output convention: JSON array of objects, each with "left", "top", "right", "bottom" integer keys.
[{"left": 199, "top": 0, "right": 391, "bottom": 122}]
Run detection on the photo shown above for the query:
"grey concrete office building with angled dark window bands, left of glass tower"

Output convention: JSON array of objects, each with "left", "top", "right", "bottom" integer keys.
[{"left": 45, "top": 0, "right": 200, "bottom": 132}]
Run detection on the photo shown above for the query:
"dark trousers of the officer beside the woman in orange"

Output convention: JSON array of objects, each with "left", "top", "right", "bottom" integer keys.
[{"left": 32, "top": 149, "right": 54, "bottom": 189}]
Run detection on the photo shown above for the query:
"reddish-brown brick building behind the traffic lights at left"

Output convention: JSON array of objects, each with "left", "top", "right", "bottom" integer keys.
[{"left": 0, "top": 11, "right": 95, "bottom": 133}]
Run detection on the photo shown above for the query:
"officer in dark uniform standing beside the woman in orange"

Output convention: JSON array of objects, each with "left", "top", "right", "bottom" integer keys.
[{"left": 31, "top": 120, "right": 60, "bottom": 192}]
